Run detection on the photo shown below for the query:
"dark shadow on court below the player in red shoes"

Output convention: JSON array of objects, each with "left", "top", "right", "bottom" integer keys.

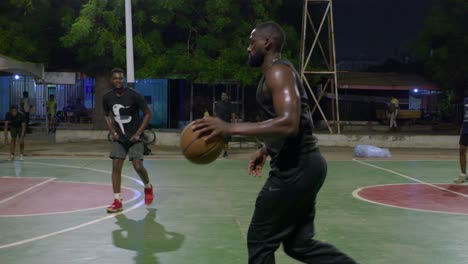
[{"left": 112, "top": 208, "right": 185, "bottom": 264}]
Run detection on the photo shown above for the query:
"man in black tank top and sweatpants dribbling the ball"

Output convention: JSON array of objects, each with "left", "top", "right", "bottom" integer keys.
[{"left": 194, "top": 22, "right": 356, "bottom": 264}]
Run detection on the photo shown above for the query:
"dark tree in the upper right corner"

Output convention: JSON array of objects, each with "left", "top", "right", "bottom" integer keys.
[{"left": 414, "top": 0, "right": 468, "bottom": 118}]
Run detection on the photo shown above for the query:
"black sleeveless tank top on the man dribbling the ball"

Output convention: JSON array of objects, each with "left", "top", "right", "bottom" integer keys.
[{"left": 257, "top": 60, "right": 318, "bottom": 170}]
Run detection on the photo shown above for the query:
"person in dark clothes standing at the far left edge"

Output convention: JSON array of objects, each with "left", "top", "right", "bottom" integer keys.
[{"left": 4, "top": 105, "right": 26, "bottom": 160}]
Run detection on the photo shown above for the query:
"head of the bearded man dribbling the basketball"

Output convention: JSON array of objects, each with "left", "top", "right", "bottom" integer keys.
[{"left": 247, "top": 21, "right": 286, "bottom": 67}]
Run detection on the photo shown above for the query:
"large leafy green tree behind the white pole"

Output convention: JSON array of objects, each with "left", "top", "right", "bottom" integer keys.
[{"left": 62, "top": 0, "right": 300, "bottom": 128}]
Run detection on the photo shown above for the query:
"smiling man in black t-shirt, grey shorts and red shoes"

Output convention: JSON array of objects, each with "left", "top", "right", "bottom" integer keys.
[{"left": 102, "top": 69, "right": 153, "bottom": 213}]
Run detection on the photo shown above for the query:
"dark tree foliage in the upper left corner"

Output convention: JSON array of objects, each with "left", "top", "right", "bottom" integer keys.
[{"left": 0, "top": 0, "right": 83, "bottom": 69}]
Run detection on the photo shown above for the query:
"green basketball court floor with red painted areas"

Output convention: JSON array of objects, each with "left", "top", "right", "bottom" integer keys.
[{"left": 0, "top": 158, "right": 468, "bottom": 264}]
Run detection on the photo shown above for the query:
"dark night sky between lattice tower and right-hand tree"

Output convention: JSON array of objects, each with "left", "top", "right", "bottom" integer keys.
[{"left": 333, "top": 0, "right": 433, "bottom": 60}]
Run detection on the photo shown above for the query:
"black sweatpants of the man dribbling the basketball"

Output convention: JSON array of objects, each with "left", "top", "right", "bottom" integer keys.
[{"left": 247, "top": 151, "right": 356, "bottom": 264}]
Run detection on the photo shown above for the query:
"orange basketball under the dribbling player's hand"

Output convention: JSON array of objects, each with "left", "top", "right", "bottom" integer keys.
[{"left": 180, "top": 123, "right": 224, "bottom": 164}]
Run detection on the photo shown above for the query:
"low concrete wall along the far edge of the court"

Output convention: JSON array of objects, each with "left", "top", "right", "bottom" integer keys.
[{"left": 56, "top": 130, "right": 459, "bottom": 149}]
